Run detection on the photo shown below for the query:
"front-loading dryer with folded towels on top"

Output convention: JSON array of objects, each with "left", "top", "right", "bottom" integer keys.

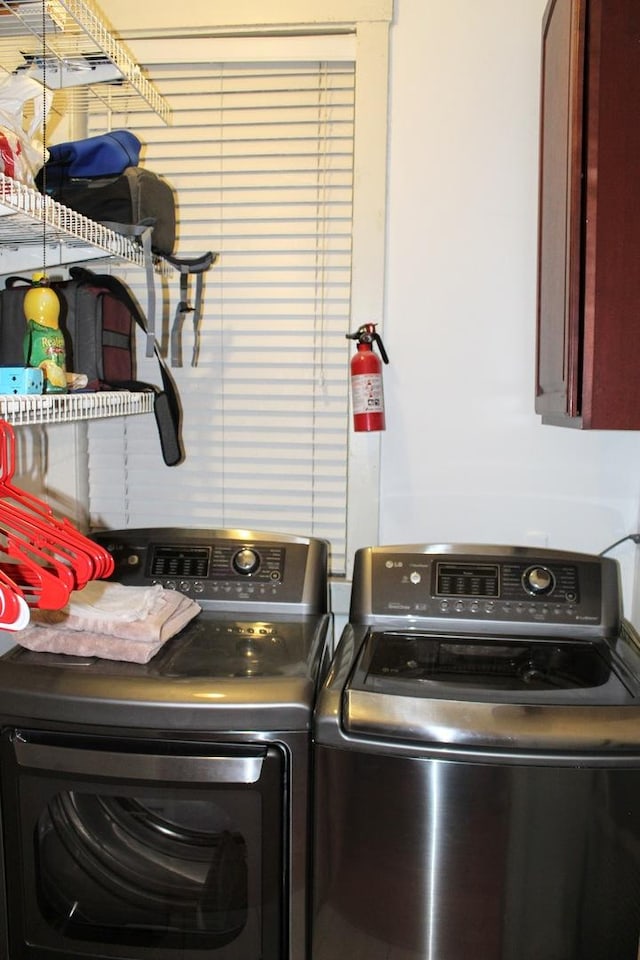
[{"left": 0, "top": 529, "right": 331, "bottom": 960}]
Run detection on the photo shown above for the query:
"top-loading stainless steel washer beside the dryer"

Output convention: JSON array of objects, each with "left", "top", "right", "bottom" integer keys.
[{"left": 312, "top": 544, "right": 640, "bottom": 960}]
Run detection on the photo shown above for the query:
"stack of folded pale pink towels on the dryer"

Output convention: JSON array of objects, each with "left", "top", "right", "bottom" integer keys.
[{"left": 6, "top": 584, "right": 201, "bottom": 663}]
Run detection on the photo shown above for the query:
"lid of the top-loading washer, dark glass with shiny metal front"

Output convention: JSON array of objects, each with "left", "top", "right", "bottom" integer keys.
[{"left": 342, "top": 632, "right": 640, "bottom": 750}]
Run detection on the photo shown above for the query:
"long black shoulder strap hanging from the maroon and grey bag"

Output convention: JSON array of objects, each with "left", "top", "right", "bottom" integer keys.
[{"left": 69, "top": 267, "right": 184, "bottom": 467}]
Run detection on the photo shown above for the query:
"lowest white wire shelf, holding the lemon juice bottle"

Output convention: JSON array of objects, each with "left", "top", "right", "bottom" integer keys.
[{"left": 0, "top": 390, "right": 155, "bottom": 426}]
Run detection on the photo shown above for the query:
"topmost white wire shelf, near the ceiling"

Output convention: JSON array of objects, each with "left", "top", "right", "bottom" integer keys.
[{"left": 0, "top": 0, "right": 171, "bottom": 124}]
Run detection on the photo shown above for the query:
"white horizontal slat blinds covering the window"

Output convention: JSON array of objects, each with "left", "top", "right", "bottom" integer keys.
[{"left": 84, "top": 48, "right": 355, "bottom": 575}]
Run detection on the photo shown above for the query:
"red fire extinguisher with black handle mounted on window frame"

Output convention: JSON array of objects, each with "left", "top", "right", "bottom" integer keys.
[{"left": 346, "top": 323, "right": 389, "bottom": 433}]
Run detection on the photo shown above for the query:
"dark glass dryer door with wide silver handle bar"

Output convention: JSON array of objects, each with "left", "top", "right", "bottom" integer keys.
[{"left": 2, "top": 730, "right": 285, "bottom": 960}]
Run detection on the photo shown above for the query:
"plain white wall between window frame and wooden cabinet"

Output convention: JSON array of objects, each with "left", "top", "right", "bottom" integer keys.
[{"left": 380, "top": 0, "right": 640, "bottom": 619}]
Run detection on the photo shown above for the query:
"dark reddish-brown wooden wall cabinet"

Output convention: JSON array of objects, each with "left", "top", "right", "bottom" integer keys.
[{"left": 536, "top": 0, "right": 640, "bottom": 430}]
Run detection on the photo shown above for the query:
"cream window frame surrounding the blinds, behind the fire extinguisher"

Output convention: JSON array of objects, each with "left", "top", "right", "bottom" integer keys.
[{"left": 124, "top": 0, "right": 393, "bottom": 580}]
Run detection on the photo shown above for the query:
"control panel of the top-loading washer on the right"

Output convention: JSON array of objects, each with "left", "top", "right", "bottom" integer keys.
[{"left": 350, "top": 544, "right": 621, "bottom": 635}]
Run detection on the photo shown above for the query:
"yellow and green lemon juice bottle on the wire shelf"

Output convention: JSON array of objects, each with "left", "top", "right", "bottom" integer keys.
[{"left": 24, "top": 273, "right": 67, "bottom": 393}]
